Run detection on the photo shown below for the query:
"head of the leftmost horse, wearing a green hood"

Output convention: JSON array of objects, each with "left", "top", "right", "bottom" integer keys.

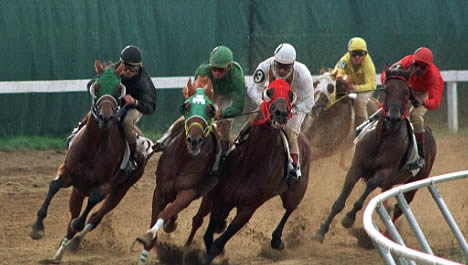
[{"left": 89, "top": 59, "right": 125, "bottom": 129}]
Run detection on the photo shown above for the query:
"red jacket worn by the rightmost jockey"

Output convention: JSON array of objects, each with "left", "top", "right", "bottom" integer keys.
[{"left": 380, "top": 55, "right": 444, "bottom": 110}]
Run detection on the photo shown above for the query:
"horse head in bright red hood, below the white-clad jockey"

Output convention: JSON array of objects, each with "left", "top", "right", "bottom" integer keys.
[{"left": 262, "top": 79, "right": 295, "bottom": 129}]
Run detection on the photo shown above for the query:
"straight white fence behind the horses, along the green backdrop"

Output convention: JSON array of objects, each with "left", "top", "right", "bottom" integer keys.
[{"left": 0, "top": 70, "right": 468, "bottom": 129}]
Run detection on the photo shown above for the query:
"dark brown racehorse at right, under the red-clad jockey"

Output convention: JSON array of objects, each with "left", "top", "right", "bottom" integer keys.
[{"left": 313, "top": 69, "right": 437, "bottom": 242}]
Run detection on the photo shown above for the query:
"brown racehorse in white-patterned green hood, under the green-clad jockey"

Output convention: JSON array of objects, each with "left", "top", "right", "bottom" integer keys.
[{"left": 136, "top": 78, "right": 220, "bottom": 264}]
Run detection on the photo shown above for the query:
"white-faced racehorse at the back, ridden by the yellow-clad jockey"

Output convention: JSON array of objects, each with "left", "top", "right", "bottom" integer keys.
[{"left": 304, "top": 70, "right": 380, "bottom": 169}]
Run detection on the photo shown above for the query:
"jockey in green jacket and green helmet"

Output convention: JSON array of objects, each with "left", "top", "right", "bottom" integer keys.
[{"left": 153, "top": 45, "right": 246, "bottom": 152}]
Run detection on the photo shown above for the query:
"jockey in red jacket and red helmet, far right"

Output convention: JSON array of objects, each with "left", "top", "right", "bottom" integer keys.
[{"left": 380, "top": 47, "right": 444, "bottom": 168}]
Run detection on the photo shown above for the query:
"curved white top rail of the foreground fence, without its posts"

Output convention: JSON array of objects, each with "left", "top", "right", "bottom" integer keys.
[{"left": 363, "top": 170, "right": 468, "bottom": 265}]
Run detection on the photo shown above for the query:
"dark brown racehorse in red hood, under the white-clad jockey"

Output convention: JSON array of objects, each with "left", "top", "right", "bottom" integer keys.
[{"left": 186, "top": 79, "right": 310, "bottom": 264}]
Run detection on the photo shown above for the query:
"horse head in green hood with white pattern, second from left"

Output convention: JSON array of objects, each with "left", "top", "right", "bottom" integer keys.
[{"left": 182, "top": 88, "right": 216, "bottom": 156}]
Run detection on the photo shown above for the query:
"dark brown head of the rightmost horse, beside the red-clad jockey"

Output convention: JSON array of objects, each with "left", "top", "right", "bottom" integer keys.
[{"left": 382, "top": 68, "right": 410, "bottom": 128}]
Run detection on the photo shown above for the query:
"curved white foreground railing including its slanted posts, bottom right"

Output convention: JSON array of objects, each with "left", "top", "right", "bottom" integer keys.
[{"left": 363, "top": 170, "right": 468, "bottom": 265}]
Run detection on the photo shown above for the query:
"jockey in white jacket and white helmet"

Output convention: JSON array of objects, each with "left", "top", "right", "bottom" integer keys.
[{"left": 248, "top": 43, "right": 314, "bottom": 184}]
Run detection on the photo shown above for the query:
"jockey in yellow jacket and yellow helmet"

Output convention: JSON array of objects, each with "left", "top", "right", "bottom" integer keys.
[{"left": 334, "top": 37, "right": 377, "bottom": 127}]
